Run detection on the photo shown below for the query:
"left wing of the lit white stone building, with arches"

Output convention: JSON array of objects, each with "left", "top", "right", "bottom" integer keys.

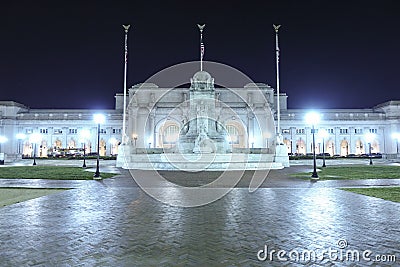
[{"left": 0, "top": 101, "right": 122, "bottom": 160}]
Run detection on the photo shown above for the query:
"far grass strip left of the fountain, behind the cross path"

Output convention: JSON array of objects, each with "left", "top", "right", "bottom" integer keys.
[{"left": 0, "top": 166, "right": 116, "bottom": 180}]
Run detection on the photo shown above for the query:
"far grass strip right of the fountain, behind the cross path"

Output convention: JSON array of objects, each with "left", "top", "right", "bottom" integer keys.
[{"left": 291, "top": 165, "right": 400, "bottom": 180}]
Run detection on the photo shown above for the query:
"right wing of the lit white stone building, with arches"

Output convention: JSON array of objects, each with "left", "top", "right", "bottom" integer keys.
[{"left": 281, "top": 101, "right": 400, "bottom": 157}]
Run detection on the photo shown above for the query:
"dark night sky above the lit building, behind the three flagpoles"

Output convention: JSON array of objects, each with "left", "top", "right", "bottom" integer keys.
[{"left": 0, "top": 0, "right": 400, "bottom": 108}]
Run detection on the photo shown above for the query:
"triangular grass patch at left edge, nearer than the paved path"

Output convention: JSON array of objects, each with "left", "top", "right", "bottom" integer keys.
[{"left": 0, "top": 188, "right": 65, "bottom": 207}]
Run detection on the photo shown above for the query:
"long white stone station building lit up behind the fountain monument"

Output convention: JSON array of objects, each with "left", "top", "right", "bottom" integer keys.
[{"left": 0, "top": 72, "right": 400, "bottom": 161}]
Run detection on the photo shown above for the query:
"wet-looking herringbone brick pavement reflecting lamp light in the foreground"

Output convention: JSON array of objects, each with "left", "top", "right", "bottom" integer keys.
[{"left": 0, "top": 163, "right": 400, "bottom": 266}]
